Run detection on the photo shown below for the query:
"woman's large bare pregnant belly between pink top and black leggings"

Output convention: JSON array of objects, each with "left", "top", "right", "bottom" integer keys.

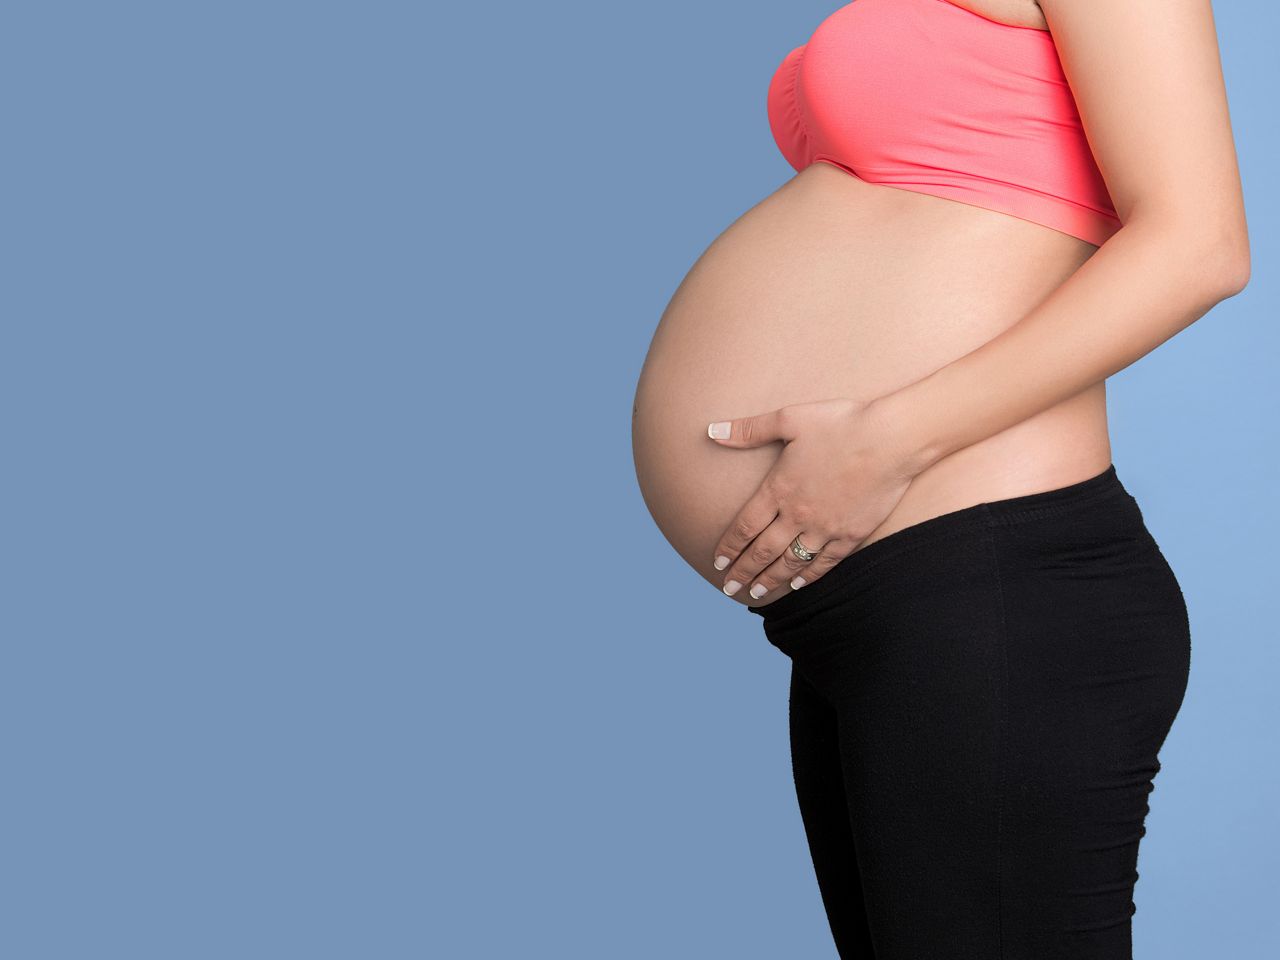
[{"left": 632, "top": 163, "right": 1111, "bottom": 605}]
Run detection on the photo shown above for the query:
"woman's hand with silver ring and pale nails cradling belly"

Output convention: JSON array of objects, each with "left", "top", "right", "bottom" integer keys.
[{"left": 707, "top": 398, "right": 919, "bottom": 599}]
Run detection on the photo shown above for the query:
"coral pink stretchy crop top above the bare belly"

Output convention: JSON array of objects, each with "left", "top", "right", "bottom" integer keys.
[{"left": 768, "top": 0, "right": 1120, "bottom": 246}]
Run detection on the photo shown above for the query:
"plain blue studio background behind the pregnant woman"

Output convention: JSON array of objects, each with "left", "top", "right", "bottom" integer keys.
[{"left": 0, "top": 0, "right": 1280, "bottom": 960}]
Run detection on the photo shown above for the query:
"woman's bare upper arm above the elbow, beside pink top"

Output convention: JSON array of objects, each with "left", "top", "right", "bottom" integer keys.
[{"left": 1039, "top": 0, "right": 1249, "bottom": 278}]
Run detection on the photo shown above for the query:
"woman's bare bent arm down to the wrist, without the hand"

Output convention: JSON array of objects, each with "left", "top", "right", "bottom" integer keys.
[{"left": 874, "top": 0, "right": 1249, "bottom": 475}]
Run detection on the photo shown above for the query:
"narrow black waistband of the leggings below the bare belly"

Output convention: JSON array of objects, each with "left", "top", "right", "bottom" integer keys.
[{"left": 748, "top": 463, "right": 1135, "bottom": 621}]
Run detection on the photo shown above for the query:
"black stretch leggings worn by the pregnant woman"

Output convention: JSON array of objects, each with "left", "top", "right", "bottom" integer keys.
[{"left": 748, "top": 465, "right": 1190, "bottom": 960}]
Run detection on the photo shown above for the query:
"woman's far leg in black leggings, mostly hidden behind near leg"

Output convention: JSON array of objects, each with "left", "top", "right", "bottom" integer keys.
[{"left": 790, "top": 668, "right": 874, "bottom": 960}]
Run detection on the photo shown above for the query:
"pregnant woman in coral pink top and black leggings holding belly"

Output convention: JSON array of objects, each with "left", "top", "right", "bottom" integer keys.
[{"left": 632, "top": 0, "right": 1249, "bottom": 960}]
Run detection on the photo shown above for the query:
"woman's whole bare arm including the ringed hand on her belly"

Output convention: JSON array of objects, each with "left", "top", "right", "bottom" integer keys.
[{"left": 708, "top": 0, "right": 1249, "bottom": 598}]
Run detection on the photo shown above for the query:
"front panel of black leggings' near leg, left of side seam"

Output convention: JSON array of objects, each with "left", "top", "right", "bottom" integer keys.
[{"left": 790, "top": 529, "right": 1011, "bottom": 960}]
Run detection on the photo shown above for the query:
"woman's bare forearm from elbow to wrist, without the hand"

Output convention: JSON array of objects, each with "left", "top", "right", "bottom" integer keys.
[{"left": 876, "top": 216, "right": 1248, "bottom": 475}]
